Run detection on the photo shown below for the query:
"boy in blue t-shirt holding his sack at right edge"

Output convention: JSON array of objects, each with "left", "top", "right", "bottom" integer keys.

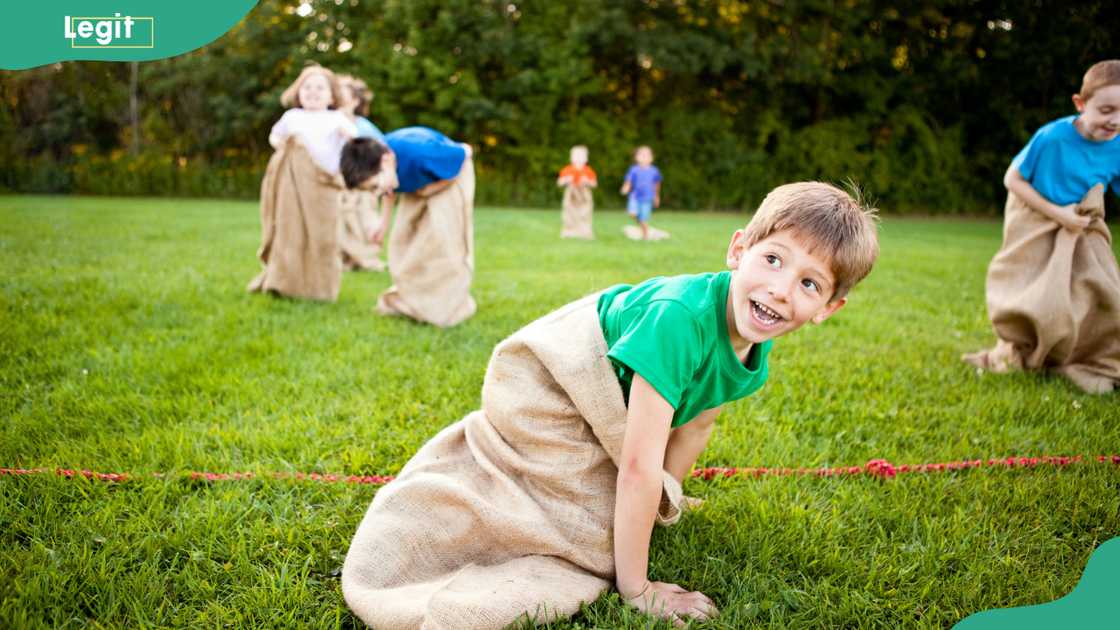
[{"left": 962, "top": 59, "right": 1120, "bottom": 393}]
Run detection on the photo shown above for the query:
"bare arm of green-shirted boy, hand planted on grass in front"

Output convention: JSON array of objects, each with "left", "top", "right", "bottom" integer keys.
[{"left": 614, "top": 373, "right": 717, "bottom": 623}]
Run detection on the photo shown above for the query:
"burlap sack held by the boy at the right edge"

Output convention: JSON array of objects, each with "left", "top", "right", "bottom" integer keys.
[{"left": 964, "top": 180, "right": 1120, "bottom": 393}]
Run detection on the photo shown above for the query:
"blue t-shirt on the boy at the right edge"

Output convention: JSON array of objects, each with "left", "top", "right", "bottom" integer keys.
[{"left": 1011, "top": 115, "right": 1120, "bottom": 200}]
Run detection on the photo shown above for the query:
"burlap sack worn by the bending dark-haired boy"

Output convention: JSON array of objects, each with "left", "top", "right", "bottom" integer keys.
[{"left": 377, "top": 157, "right": 476, "bottom": 326}]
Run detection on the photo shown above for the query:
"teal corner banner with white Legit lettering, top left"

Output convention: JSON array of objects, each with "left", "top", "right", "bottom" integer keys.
[{"left": 0, "top": 0, "right": 256, "bottom": 70}]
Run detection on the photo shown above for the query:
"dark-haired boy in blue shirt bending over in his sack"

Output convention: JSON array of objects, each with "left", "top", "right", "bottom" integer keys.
[{"left": 342, "top": 127, "right": 477, "bottom": 327}]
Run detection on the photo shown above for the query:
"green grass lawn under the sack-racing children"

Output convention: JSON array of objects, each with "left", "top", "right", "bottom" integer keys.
[{"left": 0, "top": 196, "right": 1120, "bottom": 628}]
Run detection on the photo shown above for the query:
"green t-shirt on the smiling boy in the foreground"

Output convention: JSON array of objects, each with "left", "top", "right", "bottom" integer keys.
[{"left": 599, "top": 271, "right": 772, "bottom": 427}]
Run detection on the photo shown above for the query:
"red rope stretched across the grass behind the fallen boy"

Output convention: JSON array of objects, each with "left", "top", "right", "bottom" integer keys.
[{"left": 0, "top": 455, "right": 1120, "bottom": 485}]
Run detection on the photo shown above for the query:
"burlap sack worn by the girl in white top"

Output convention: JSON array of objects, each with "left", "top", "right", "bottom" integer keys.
[{"left": 248, "top": 137, "right": 344, "bottom": 302}]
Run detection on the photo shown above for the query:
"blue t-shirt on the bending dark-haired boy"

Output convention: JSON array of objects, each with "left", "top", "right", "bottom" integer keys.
[{"left": 385, "top": 127, "right": 467, "bottom": 193}]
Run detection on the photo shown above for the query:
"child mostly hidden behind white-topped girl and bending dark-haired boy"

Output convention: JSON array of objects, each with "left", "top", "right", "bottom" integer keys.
[{"left": 338, "top": 74, "right": 394, "bottom": 271}]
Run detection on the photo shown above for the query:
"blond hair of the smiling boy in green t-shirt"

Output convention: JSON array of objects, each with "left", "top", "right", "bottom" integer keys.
[{"left": 744, "top": 182, "right": 879, "bottom": 302}]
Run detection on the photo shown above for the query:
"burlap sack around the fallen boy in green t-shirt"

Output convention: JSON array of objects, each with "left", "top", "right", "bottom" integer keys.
[{"left": 343, "top": 296, "right": 681, "bottom": 629}]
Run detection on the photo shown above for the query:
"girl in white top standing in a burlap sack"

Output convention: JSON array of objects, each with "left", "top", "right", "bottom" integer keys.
[{"left": 248, "top": 65, "right": 357, "bottom": 302}]
